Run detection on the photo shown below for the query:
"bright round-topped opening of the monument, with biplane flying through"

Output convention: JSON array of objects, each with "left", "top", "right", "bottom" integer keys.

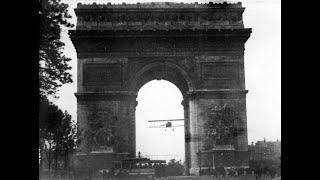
[{"left": 136, "top": 80, "right": 185, "bottom": 162}]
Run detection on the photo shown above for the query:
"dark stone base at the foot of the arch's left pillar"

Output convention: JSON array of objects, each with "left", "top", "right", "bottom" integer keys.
[{"left": 73, "top": 152, "right": 130, "bottom": 171}]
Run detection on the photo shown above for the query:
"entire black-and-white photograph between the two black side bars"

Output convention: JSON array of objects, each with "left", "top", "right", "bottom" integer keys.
[{"left": 37, "top": 0, "right": 281, "bottom": 180}]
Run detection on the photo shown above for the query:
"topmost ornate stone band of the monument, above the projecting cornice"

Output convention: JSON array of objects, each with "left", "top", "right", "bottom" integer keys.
[{"left": 74, "top": 2, "right": 245, "bottom": 30}]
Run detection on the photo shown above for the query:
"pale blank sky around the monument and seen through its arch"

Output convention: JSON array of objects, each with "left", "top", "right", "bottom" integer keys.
[{"left": 50, "top": 0, "right": 281, "bottom": 160}]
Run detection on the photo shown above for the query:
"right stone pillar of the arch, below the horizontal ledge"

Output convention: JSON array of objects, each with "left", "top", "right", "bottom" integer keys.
[{"left": 186, "top": 89, "right": 248, "bottom": 175}]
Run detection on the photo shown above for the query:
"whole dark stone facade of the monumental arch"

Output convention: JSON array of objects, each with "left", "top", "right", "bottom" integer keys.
[{"left": 69, "top": 3, "right": 251, "bottom": 174}]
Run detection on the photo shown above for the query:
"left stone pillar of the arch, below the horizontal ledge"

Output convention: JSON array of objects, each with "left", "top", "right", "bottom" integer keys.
[{"left": 75, "top": 91, "right": 137, "bottom": 157}]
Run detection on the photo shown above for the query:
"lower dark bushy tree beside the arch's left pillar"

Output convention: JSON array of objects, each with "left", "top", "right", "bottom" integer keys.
[{"left": 39, "top": 96, "right": 77, "bottom": 174}]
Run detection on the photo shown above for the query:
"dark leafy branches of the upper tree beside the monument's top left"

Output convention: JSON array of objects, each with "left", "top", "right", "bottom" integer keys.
[{"left": 39, "top": 0, "right": 74, "bottom": 97}]
